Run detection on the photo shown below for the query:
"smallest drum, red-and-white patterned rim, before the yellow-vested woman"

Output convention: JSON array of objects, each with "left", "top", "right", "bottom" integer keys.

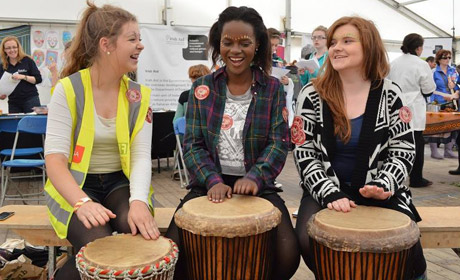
[{"left": 76, "top": 234, "right": 178, "bottom": 280}]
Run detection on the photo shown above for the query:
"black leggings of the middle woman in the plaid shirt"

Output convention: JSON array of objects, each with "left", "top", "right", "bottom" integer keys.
[{"left": 165, "top": 189, "right": 300, "bottom": 280}]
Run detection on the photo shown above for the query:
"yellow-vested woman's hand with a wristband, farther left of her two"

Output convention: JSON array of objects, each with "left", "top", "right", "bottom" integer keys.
[{"left": 75, "top": 201, "right": 116, "bottom": 229}]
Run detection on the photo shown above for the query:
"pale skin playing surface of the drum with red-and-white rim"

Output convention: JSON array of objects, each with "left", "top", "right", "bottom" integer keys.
[{"left": 83, "top": 234, "right": 172, "bottom": 269}]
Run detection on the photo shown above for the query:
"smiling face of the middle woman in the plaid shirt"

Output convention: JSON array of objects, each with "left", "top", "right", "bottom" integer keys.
[{"left": 220, "top": 21, "right": 257, "bottom": 75}]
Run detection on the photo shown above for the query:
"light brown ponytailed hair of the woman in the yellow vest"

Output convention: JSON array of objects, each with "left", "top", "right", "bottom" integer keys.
[{"left": 61, "top": 0, "right": 137, "bottom": 77}]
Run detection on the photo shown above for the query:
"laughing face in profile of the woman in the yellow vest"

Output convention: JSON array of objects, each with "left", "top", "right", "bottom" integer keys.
[{"left": 109, "top": 21, "right": 144, "bottom": 73}]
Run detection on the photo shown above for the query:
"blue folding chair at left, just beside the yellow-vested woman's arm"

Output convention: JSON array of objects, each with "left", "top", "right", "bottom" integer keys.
[{"left": 0, "top": 116, "right": 47, "bottom": 206}]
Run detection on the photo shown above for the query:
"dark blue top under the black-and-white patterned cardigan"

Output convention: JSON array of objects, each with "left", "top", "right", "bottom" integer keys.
[{"left": 331, "top": 115, "right": 363, "bottom": 184}]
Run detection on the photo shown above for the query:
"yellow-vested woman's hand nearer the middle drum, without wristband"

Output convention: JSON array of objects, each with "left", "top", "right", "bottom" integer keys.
[{"left": 128, "top": 200, "right": 160, "bottom": 239}]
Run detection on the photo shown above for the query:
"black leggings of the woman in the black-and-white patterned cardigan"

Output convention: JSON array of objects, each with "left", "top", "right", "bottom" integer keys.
[{"left": 295, "top": 195, "right": 426, "bottom": 276}]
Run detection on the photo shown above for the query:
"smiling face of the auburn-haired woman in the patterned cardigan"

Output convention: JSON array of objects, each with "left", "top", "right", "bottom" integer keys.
[{"left": 329, "top": 24, "right": 364, "bottom": 72}]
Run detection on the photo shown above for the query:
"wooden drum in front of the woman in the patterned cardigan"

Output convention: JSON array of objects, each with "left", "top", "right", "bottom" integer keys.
[{"left": 307, "top": 206, "right": 420, "bottom": 280}]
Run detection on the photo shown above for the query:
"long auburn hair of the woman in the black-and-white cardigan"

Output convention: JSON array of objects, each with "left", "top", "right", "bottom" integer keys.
[{"left": 312, "top": 17, "right": 390, "bottom": 143}]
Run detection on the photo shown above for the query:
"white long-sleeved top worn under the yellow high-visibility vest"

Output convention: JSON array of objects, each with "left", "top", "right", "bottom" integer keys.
[{"left": 45, "top": 83, "right": 152, "bottom": 204}]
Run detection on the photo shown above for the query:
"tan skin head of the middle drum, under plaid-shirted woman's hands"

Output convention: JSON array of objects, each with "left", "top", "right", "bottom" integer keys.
[{"left": 174, "top": 194, "right": 281, "bottom": 238}]
